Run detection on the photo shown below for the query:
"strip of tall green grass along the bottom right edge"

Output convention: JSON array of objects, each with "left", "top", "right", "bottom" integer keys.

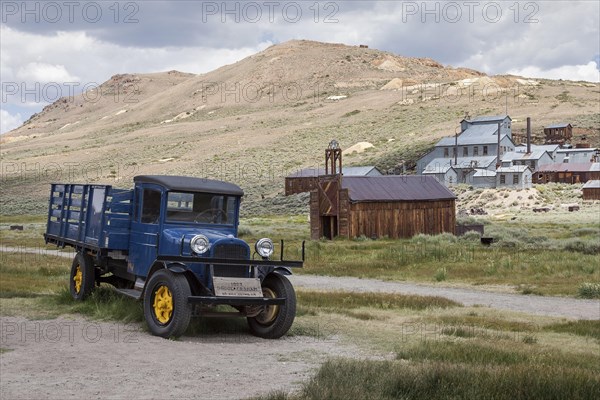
[{"left": 263, "top": 360, "right": 600, "bottom": 400}]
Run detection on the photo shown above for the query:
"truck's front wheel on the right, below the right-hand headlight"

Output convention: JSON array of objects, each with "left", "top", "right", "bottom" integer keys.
[{"left": 248, "top": 272, "right": 296, "bottom": 339}]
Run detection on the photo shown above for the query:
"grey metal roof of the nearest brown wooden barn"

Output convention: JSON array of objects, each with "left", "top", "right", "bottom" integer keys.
[{"left": 342, "top": 175, "right": 456, "bottom": 202}]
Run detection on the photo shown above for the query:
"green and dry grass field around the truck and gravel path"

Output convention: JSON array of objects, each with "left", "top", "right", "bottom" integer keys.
[{"left": 0, "top": 217, "right": 600, "bottom": 400}]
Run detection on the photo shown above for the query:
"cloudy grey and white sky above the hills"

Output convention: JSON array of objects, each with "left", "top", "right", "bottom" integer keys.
[{"left": 0, "top": 0, "right": 600, "bottom": 133}]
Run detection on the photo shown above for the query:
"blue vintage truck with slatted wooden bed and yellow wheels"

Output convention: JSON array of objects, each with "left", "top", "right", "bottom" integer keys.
[{"left": 44, "top": 175, "right": 304, "bottom": 338}]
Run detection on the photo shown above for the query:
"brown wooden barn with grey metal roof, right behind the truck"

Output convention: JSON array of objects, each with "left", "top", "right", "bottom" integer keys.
[{"left": 310, "top": 175, "right": 456, "bottom": 239}]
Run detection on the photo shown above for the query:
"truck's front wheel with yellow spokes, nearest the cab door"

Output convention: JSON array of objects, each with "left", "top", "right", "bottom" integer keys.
[{"left": 144, "top": 269, "right": 192, "bottom": 338}]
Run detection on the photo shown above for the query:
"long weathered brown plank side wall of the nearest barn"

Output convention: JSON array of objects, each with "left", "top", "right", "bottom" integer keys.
[{"left": 340, "top": 200, "right": 456, "bottom": 238}]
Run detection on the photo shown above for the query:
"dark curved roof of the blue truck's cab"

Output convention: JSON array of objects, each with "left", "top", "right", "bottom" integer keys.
[{"left": 133, "top": 175, "right": 244, "bottom": 196}]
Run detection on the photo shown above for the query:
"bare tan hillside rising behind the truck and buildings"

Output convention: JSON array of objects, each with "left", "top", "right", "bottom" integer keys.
[{"left": 0, "top": 41, "right": 600, "bottom": 214}]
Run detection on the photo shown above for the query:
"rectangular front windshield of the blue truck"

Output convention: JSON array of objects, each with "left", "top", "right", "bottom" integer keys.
[{"left": 167, "top": 192, "right": 236, "bottom": 225}]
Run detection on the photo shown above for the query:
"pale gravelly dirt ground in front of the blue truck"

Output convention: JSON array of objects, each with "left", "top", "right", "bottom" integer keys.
[{"left": 0, "top": 317, "right": 369, "bottom": 400}]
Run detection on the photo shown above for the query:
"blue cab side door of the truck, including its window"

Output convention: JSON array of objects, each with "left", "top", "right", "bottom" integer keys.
[{"left": 127, "top": 184, "right": 164, "bottom": 277}]
